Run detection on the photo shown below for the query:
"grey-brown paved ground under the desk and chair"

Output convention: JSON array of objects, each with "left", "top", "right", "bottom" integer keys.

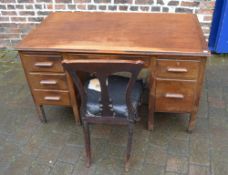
[{"left": 0, "top": 50, "right": 228, "bottom": 175}]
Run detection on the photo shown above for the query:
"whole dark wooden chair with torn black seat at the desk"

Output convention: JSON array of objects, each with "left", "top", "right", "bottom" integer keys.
[{"left": 62, "top": 59, "right": 144, "bottom": 171}]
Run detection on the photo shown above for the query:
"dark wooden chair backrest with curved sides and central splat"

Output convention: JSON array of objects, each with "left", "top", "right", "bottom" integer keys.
[{"left": 62, "top": 59, "right": 144, "bottom": 120}]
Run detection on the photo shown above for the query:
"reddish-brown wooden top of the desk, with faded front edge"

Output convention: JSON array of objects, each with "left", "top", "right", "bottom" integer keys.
[{"left": 17, "top": 12, "right": 209, "bottom": 56}]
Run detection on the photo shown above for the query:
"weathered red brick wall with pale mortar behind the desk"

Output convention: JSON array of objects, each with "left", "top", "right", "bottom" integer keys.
[{"left": 0, "top": 0, "right": 214, "bottom": 48}]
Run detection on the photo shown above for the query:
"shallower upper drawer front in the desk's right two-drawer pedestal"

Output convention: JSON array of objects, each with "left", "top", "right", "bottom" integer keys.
[{"left": 157, "top": 59, "right": 200, "bottom": 79}]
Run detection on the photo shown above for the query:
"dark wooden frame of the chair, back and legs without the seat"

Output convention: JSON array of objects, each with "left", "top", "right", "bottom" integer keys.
[{"left": 62, "top": 60, "right": 144, "bottom": 171}]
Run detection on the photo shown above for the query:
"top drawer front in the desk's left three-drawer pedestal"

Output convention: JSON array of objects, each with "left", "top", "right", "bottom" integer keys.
[{"left": 21, "top": 54, "right": 64, "bottom": 72}]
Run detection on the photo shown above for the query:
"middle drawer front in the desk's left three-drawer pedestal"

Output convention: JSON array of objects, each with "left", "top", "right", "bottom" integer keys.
[{"left": 28, "top": 72, "right": 68, "bottom": 90}]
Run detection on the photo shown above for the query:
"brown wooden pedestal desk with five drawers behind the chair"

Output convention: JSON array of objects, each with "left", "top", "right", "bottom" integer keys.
[{"left": 17, "top": 12, "right": 209, "bottom": 130}]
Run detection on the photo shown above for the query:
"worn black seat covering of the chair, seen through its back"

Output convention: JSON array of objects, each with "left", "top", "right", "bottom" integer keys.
[{"left": 85, "top": 75, "right": 143, "bottom": 118}]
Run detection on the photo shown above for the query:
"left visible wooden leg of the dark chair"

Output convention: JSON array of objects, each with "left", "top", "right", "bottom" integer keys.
[{"left": 83, "top": 122, "right": 91, "bottom": 168}]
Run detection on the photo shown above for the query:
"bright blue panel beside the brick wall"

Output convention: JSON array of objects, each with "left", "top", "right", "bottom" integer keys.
[{"left": 209, "top": 0, "right": 228, "bottom": 53}]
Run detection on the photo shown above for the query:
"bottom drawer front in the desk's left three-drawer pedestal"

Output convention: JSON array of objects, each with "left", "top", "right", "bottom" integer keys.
[{"left": 33, "top": 90, "right": 70, "bottom": 106}]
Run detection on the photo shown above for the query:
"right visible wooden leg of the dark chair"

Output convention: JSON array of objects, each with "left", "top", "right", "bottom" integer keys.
[{"left": 125, "top": 123, "right": 134, "bottom": 171}]
